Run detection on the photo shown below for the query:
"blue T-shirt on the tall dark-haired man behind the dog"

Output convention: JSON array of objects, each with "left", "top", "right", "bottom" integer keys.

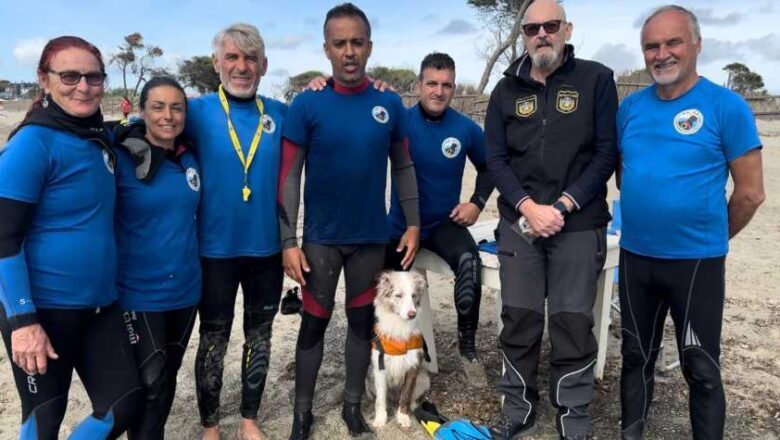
[{"left": 284, "top": 82, "right": 406, "bottom": 245}]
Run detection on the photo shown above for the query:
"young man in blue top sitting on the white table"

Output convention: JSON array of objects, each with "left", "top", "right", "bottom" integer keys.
[{"left": 385, "top": 53, "right": 493, "bottom": 386}]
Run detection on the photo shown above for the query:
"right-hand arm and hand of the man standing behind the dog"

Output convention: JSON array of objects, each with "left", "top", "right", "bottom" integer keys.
[{"left": 390, "top": 137, "right": 420, "bottom": 269}]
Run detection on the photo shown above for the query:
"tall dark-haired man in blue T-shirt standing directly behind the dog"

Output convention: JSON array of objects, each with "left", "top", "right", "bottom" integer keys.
[{"left": 279, "top": 3, "right": 419, "bottom": 440}]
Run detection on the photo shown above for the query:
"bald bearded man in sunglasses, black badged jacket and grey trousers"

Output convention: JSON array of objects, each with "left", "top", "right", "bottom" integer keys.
[{"left": 485, "top": 0, "right": 617, "bottom": 439}]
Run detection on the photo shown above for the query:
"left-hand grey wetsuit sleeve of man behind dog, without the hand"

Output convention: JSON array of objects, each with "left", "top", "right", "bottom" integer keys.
[{"left": 277, "top": 138, "right": 306, "bottom": 249}]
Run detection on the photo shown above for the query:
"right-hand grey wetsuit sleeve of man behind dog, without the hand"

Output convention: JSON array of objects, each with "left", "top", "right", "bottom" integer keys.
[{"left": 390, "top": 138, "right": 420, "bottom": 226}]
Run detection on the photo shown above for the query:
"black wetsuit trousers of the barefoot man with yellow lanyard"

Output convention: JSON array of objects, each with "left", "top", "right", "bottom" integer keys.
[{"left": 195, "top": 254, "right": 284, "bottom": 427}]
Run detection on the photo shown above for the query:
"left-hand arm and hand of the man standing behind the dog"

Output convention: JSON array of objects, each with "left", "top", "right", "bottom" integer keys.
[{"left": 277, "top": 138, "right": 309, "bottom": 286}]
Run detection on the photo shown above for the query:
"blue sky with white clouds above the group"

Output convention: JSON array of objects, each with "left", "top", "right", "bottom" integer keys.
[{"left": 0, "top": 0, "right": 780, "bottom": 96}]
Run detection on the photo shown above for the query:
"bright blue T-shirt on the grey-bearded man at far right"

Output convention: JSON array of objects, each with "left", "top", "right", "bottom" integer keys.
[{"left": 617, "top": 78, "right": 761, "bottom": 259}]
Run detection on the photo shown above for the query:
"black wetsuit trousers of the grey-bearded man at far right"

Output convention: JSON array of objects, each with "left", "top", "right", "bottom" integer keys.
[{"left": 619, "top": 250, "right": 726, "bottom": 439}]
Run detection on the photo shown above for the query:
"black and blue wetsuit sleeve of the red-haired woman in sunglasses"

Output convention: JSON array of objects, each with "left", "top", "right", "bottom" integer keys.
[{"left": 0, "top": 197, "right": 38, "bottom": 331}]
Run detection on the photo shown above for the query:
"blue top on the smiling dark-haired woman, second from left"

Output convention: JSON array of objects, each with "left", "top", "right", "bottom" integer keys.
[{"left": 116, "top": 140, "right": 201, "bottom": 312}]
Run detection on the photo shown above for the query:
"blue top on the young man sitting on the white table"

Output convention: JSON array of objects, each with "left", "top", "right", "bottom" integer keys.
[{"left": 388, "top": 104, "right": 489, "bottom": 240}]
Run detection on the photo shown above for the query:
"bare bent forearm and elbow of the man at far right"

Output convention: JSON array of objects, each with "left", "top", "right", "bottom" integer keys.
[{"left": 728, "top": 148, "right": 765, "bottom": 238}]
